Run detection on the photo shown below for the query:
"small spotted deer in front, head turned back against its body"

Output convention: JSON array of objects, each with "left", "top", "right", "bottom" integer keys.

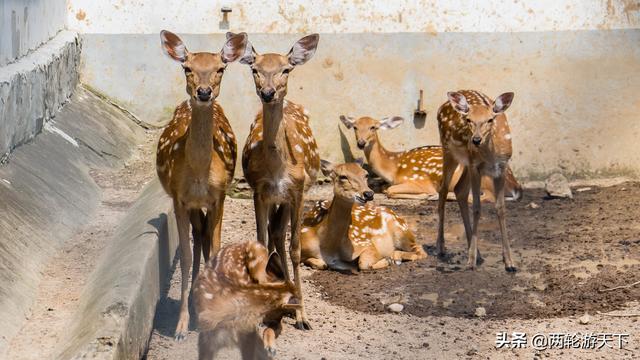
[{"left": 193, "top": 241, "right": 299, "bottom": 360}]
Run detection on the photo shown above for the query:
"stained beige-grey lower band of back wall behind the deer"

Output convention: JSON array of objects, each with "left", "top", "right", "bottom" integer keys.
[{"left": 82, "top": 30, "right": 640, "bottom": 178}]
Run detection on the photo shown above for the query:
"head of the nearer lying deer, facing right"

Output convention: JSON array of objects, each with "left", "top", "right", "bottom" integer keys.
[{"left": 321, "top": 159, "right": 373, "bottom": 204}]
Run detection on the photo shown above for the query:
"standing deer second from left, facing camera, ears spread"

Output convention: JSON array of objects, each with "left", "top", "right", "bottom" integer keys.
[{"left": 240, "top": 34, "right": 320, "bottom": 330}]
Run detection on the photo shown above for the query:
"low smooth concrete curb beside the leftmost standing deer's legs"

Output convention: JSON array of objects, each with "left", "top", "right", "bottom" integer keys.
[{"left": 59, "top": 179, "right": 178, "bottom": 359}]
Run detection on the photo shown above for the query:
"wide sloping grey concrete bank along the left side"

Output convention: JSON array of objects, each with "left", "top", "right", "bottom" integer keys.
[{"left": 0, "top": 88, "right": 143, "bottom": 356}]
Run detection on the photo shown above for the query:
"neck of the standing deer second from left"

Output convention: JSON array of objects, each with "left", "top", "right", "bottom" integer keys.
[{"left": 262, "top": 101, "right": 289, "bottom": 171}]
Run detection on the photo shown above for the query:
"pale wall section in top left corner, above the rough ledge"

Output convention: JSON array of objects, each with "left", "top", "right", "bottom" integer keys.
[{"left": 0, "top": 0, "right": 67, "bottom": 66}]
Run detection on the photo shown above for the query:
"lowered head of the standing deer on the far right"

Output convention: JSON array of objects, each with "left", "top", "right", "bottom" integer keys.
[{"left": 447, "top": 91, "right": 513, "bottom": 147}]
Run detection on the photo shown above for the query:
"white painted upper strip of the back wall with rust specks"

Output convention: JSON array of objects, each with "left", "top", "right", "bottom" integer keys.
[{"left": 67, "top": 0, "right": 640, "bottom": 34}]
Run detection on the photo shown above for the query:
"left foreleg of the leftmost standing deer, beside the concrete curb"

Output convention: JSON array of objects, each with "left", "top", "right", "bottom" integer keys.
[{"left": 174, "top": 201, "right": 192, "bottom": 341}]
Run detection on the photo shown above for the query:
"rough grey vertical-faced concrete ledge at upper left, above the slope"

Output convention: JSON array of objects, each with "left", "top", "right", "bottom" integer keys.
[{"left": 0, "top": 31, "right": 81, "bottom": 158}]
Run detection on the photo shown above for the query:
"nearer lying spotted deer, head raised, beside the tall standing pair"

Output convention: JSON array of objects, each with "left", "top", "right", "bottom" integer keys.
[{"left": 301, "top": 160, "right": 427, "bottom": 271}]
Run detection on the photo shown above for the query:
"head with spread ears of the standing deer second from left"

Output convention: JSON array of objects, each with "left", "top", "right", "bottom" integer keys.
[{"left": 240, "top": 34, "right": 320, "bottom": 103}]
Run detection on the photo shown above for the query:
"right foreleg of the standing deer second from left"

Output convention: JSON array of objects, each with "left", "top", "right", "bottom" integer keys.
[{"left": 285, "top": 195, "right": 311, "bottom": 330}]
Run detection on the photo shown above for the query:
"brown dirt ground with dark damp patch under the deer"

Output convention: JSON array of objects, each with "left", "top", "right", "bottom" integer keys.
[{"left": 147, "top": 183, "right": 640, "bottom": 360}]
